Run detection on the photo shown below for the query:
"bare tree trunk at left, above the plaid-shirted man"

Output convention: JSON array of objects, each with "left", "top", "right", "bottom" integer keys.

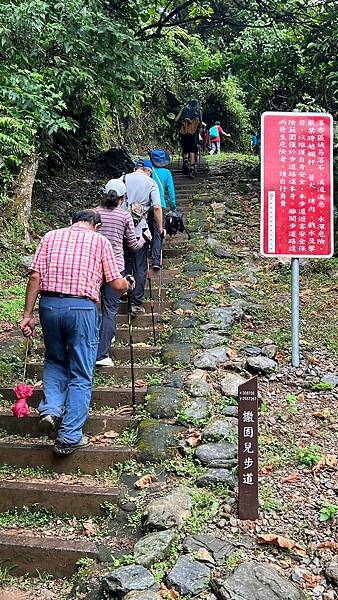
[{"left": 5, "top": 152, "right": 39, "bottom": 244}]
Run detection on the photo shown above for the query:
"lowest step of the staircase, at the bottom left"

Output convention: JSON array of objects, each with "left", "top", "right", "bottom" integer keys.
[{"left": 0, "top": 533, "right": 97, "bottom": 578}]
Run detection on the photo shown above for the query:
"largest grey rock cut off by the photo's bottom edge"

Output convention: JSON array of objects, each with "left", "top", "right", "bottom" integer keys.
[{"left": 211, "top": 561, "right": 306, "bottom": 600}]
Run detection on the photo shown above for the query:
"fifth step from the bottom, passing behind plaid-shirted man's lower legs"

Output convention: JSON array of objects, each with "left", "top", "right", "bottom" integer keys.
[{"left": 0, "top": 386, "right": 147, "bottom": 410}]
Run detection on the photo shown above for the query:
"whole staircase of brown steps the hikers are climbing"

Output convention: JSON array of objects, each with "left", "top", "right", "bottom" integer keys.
[{"left": 0, "top": 158, "right": 207, "bottom": 577}]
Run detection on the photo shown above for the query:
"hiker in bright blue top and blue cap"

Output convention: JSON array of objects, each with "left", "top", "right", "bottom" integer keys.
[{"left": 148, "top": 148, "right": 176, "bottom": 271}]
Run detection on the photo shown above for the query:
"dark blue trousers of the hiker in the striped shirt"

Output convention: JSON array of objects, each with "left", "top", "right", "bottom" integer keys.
[{"left": 97, "top": 283, "right": 121, "bottom": 360}]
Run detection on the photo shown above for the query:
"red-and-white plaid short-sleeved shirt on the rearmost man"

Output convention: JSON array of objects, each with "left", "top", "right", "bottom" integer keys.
[{"left": 31, "top": 223, "right": 121, "bottom": 302}]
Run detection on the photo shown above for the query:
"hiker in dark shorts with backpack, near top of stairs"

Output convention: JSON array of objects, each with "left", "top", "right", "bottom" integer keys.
[{"left": 175, "top": 100, "right": 202, "bottom": 178}]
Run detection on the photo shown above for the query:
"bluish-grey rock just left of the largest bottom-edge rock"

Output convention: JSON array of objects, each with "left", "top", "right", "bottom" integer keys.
[{"left": 165, "top": 556, "right": 210, "bottom": 596}]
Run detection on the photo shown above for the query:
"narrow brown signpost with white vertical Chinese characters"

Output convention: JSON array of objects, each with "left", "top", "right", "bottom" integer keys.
[{"left": 238, "top": 377, "right": 258, "bottom": 521}]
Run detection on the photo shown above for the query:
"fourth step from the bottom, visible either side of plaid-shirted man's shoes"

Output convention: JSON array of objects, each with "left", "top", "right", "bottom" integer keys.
[{"left": 0, "top": 411, "right": 131, "bottom": 437}]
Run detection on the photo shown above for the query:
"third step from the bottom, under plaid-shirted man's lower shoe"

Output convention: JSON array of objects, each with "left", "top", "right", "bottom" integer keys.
[{"left": 0, "top": 440, "right": 135, "bottom": 475}]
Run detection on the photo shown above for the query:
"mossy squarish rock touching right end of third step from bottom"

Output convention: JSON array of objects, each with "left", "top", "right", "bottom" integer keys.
[{"left": 137, "top": 419, "right": 184, "bottom": 463}]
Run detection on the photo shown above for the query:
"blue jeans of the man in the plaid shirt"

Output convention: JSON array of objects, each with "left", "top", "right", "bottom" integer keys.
[{"left": 39, "top": 296, "right": 100, "bottom": 444}]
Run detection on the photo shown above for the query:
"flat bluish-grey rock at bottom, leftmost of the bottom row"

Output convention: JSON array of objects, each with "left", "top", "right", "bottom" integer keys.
[{"left": 102, "top": 565, "right": 159, "bottom": 598}]
